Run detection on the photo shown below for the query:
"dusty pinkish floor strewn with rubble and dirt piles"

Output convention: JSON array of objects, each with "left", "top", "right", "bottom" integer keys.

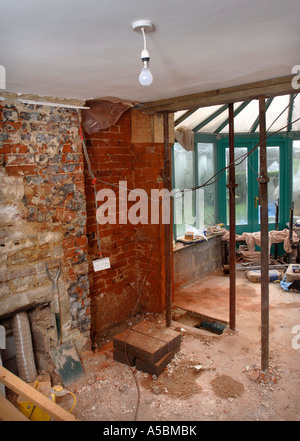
[{"left": 51, "top": 271, "right": 300, "bottom": 422}]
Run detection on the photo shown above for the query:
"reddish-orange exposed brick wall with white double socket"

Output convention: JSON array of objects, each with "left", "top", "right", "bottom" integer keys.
[{"left": 85, "top": 110, "right": 169, "bottom": 337}]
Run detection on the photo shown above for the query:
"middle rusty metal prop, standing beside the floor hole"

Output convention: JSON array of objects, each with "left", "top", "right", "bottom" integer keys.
[{"left": 227, "top": 103, "right": 237, "bottom": 331}]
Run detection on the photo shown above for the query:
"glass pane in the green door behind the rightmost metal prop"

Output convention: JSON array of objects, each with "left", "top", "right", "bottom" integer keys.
[{"left": 258, "top": 146, "right": 279, "bottom": 223}]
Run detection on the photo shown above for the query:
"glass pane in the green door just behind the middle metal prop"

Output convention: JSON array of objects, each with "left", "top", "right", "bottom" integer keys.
[{"left": 226, "top": 147, "right": 248, "bottom": 225}]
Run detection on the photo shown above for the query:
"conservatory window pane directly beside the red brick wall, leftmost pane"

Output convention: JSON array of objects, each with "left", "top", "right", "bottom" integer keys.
[{"left": 173, "top": 142, "right": 195, "bottom": 239}]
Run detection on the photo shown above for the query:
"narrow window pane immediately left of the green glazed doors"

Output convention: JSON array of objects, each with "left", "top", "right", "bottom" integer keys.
[{"left": 197, "top": 143, "right": 215, "bottom": 228}]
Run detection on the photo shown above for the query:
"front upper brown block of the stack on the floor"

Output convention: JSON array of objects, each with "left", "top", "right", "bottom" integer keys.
[{"left": 113, "top": 329, "right": 168, "bottom": 363}]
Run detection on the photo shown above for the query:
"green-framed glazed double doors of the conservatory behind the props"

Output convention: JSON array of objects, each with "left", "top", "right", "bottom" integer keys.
[{"left": 218, "top": 139, "right": 288, "bottom": 234}]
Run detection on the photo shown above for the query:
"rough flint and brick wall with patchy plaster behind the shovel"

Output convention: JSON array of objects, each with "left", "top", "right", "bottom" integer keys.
[{"left": 0, "top": 103, "right": 90, "bottom": 366}]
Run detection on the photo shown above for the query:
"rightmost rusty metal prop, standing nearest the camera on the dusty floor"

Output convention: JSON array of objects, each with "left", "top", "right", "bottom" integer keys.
[{"left": 257, "top": 97, "right": 269, "bottom": 371}]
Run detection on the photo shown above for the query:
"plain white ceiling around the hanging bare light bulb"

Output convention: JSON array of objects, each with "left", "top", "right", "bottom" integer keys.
[{"left": 0, "top": 0, "right": 300, "bottom": 102}]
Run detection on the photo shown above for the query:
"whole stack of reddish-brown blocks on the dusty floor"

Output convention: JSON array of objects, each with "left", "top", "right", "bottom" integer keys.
[{"left": 113, "top": 321, "right": 181, "bottom": 376}]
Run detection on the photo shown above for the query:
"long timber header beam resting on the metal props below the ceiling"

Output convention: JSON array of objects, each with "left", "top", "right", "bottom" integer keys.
[{"left": 135, "top": 75, "right": 295, "bottom": 113}]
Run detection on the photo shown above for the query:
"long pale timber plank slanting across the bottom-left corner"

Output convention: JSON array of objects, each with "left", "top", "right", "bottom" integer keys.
[{"left": 0, "top": 366, "right": 76, "bottom": 421}]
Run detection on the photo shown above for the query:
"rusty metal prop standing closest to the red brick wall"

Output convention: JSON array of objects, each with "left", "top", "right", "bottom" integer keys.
[{"left": 163, "top": 112, "right": 172, "bottom": 327}]
